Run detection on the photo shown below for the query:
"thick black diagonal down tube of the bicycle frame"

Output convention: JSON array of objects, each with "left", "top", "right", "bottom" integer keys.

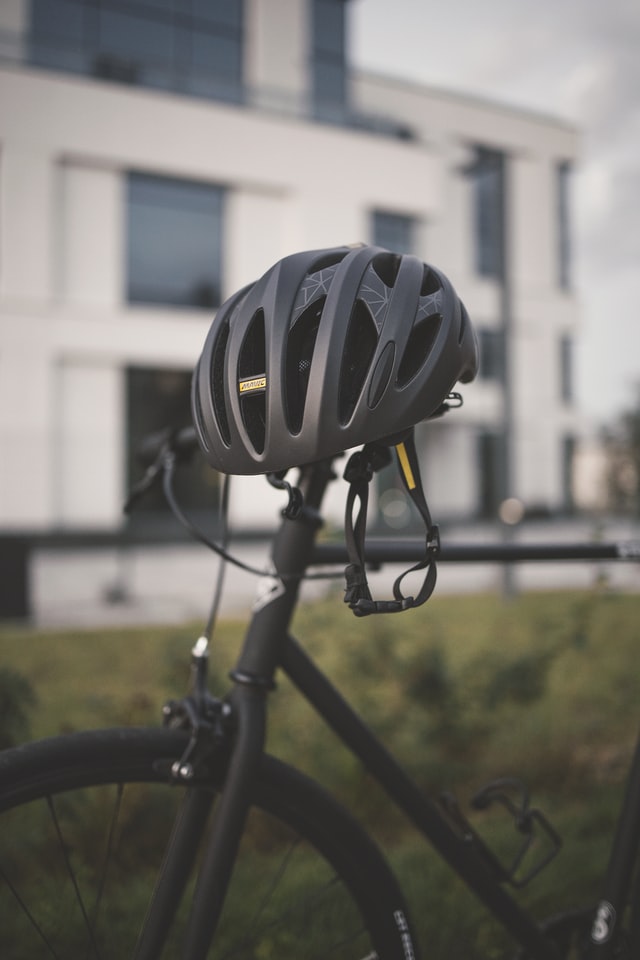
[{"left": 281, "top": 637, "right": 559, "bottom": 960}]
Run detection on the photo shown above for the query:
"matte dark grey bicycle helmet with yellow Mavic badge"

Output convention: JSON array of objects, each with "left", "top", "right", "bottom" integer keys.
[{"left": 192, "top": 245, "right": 478, "bottom": 474}]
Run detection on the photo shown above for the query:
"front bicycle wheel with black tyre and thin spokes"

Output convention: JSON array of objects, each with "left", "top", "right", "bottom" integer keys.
[{"left": 0, "top": 729, "right": 417, "bottom": 960}]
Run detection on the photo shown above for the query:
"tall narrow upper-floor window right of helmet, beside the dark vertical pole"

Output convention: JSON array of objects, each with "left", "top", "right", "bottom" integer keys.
[{"left": 467, "top": 147, "right": 505, "bottom": 280}]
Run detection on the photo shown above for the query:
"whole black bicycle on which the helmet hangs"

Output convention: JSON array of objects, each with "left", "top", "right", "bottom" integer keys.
[{"left": 0, "top": 422, "right": 640, "bottom": 960}]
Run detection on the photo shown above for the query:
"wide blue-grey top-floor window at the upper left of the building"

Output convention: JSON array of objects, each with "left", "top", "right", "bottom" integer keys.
[{"left": 30, "top": 0, "right": 244, "bottom": 102}]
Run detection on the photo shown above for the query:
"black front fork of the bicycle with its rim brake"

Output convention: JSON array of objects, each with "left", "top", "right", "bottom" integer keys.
[{"left": 134, "top": 638, "right": 268, "bottom": 960}]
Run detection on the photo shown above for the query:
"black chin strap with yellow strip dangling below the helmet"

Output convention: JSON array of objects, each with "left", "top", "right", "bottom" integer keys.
[{"left": 344, "top": 430, "right": 440, "bottom": 617}]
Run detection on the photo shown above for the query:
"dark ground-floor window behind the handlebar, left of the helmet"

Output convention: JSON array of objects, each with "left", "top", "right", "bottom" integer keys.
[{"left": 126, "top": 367, "right": 218, "bottom": 532}]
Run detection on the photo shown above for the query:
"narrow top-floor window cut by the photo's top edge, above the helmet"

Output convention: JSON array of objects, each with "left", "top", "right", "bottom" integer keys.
[{"left": 311, "top": 0, "right": 347, "bottom": 123}]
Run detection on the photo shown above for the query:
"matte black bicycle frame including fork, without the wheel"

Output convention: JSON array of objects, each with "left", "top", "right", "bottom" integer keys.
[{"left": 136, "top": 463, "right": 640, "bottom": 960}]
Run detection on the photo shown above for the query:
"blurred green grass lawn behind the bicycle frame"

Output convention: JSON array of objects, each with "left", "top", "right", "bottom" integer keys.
[{"left": 0, "top": 589, "right": 640, "bottom": 957}]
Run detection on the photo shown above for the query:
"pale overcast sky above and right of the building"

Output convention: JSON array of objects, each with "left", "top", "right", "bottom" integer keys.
[{"left": 350, "top": 0, "right": 640, "bottom": 423}]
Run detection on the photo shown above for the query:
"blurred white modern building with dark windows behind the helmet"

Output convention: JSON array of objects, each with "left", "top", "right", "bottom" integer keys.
[{"left": 0, "top": 0, "right": 578, "bottom": 616}]
